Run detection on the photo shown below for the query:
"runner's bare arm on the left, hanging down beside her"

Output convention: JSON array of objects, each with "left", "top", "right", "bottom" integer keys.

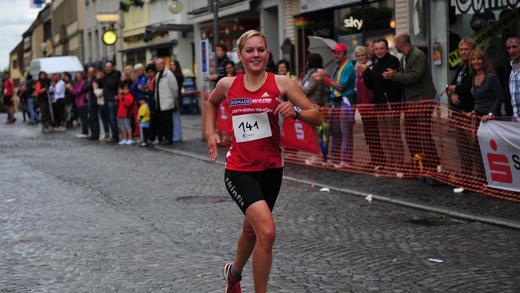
[{"left": 204, "top": 77, "right": 234, "bottom": 160}]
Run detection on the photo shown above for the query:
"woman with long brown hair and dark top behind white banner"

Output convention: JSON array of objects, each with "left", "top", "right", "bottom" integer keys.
[{"left": 469, "top": 49, "right": 504, "bottom": 122}]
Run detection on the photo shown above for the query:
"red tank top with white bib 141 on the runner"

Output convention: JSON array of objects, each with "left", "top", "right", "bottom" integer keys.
[{"left": 226, "top": 73, "right": 283, "bottom": 171}]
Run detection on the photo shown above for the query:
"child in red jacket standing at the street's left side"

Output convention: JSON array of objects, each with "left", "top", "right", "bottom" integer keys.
[{"left": 117, "top": 82, "right": 135, "bottom": 145}]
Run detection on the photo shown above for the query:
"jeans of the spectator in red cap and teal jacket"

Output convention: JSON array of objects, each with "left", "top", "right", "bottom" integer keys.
[{"left": 329, "top": 103, "right": 355, "bottom": 163}]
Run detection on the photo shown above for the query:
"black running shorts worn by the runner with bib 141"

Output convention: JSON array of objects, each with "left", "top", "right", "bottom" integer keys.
[{"left": 224, "top": 168, "right": 283, "bottom": 215}]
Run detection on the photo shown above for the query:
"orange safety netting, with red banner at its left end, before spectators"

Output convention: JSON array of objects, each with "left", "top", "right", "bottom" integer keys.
[{"left": 219, "top": 100, "right": 520, "bottom": 202}]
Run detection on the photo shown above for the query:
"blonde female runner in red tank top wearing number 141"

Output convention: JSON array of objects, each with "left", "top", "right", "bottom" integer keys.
[{"left": 206, "top": 30, "right": 322, "bottom": 293}]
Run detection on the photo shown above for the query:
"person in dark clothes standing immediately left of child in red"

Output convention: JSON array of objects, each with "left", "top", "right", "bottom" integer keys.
[{"left": 103, "top": 62, "right": 121, "bottom": 143}]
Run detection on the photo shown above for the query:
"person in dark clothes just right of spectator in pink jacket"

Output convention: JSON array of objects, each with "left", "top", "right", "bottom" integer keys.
[{"left": 85, "top": 67, "right": 103, "bottom": 140}]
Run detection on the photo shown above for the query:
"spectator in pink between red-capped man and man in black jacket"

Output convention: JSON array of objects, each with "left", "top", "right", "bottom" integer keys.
[{"left": 354, "top": 46, "right": 384, "bottom": 169}]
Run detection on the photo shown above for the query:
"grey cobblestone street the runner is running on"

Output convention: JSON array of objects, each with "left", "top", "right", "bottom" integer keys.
[{"left": 0, "top": 117, "right": 520, "bottom": 293}]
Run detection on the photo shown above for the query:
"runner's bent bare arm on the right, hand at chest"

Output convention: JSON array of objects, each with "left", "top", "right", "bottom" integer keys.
[{"left": 275, "top": 75, "right": 323, "bottom": 126}]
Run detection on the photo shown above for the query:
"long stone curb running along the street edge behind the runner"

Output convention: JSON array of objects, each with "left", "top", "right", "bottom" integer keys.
[{"left": 155, "top": 146, "right": 520, "bottom": 230}]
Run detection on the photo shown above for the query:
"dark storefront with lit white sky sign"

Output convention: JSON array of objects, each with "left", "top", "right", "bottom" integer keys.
[{"left": 296, "top": 0, "right": 395, "bottom": 75}]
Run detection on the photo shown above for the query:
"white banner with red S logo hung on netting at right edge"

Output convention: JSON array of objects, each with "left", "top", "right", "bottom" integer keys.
[{"left": 477, "top": 121, "right": 520, "bottom": 191}]
